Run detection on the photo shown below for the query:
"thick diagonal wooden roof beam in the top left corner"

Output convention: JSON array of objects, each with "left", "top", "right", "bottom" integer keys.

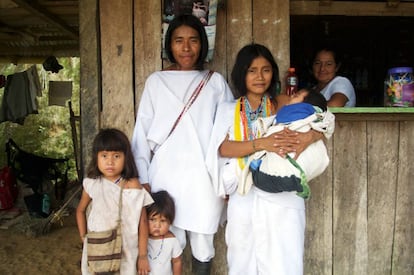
[{"left": 12, "top": 0, "right": 79, "bottom": 40}]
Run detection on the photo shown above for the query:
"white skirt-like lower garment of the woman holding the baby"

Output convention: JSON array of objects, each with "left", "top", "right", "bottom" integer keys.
[{"left": 226, "top": 188, "right": 305, "bottom": 275}]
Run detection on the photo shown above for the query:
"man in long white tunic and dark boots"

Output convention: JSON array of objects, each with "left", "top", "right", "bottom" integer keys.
[{"left": 132, "top": 15, "right": 233, "bottom": 274}]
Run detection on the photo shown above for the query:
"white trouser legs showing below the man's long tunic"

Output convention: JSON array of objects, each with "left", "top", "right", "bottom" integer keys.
[{"left": 170, "top": 225, "right": 215, "bottom": 262}]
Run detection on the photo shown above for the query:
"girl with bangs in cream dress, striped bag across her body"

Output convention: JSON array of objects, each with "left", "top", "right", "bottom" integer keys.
[{"left": 76, "top": 129, "right": 153, "bottom": 274}]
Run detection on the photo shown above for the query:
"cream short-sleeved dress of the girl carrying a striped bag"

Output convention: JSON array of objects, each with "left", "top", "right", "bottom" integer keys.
[{"left": 82, "top": 178, "right": 153, "bottom": 275}]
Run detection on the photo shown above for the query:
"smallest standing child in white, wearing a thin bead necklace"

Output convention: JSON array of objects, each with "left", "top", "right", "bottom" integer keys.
[{"left": 147, "top": 191, "right": 183, "bottom": 275}]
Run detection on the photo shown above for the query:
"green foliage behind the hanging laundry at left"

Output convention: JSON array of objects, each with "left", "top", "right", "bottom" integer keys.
[{"left": 0, "top": 58, "right": 80, "bottom": 180}]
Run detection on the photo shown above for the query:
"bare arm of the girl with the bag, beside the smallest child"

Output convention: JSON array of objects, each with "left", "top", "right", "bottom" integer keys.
[{"left": 137, "top": 207, "right": 151, "bottom": 274}]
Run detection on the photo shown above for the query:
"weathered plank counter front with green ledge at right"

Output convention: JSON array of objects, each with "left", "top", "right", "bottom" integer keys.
[{"left": 305, "top": 108, "right": 414, "bottom": 274}]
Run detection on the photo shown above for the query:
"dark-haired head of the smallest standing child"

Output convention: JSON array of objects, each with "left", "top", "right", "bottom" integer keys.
[{"left": 147, "top": 191, "right": 175, "bottom": 237}]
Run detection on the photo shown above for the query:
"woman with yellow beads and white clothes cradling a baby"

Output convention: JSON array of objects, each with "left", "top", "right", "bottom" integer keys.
[{"left": 212, "top": 44, "right": 334, "bottom": 275}]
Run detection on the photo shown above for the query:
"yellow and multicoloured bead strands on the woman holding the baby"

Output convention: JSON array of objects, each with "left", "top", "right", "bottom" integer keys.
[{"left": 234, "top": 95, "right": 272, "bottom": 169}]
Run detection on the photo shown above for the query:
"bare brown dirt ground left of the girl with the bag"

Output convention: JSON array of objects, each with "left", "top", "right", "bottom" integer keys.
[{"left": 0, "top": 212, "right": 82, "bottom": 275}]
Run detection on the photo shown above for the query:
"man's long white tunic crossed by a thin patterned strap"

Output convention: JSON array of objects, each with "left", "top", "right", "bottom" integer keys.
[{"left": 131, "top": 71, "right": 233, "bottom": 234}]
